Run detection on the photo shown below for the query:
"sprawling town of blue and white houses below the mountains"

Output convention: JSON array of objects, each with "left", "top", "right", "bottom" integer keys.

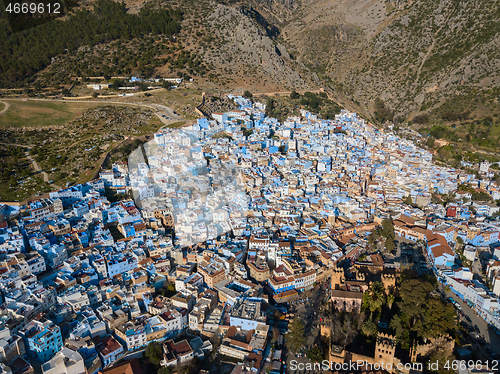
[{"left": 0, "top": 95, "right": 500, "bottom": 374}]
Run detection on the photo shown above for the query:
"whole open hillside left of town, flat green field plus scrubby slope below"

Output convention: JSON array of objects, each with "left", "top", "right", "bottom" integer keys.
[{"left": 0, "top": 87, "right": 205, "bottom": 201}]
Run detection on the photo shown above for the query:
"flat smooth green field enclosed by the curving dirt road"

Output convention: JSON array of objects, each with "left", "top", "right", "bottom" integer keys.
[{"left": 0, "top": 100, "right": 114, "bottom": 128}]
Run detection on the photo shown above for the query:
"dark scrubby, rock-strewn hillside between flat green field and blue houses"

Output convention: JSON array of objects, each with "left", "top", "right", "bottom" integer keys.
[{"left": 0, "top": 103, "right": 163, "bottom": 201}]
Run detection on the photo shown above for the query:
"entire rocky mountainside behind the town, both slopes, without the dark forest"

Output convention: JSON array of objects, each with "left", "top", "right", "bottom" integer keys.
[{"left": 1, "top": 0, "right": 500, "bottom": 125}]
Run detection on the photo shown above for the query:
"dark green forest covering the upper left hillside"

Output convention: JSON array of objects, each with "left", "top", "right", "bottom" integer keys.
[{"left": 0, "top": 0, "right": 182, "bottom": 86}]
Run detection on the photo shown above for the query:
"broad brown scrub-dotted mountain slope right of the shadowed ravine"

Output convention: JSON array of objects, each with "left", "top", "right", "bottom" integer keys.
[{"left": 246, "top": 0, "right": 500, "bottom": 120}]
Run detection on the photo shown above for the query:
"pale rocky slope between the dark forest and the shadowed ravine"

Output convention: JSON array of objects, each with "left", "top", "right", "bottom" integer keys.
[{"left": 166, "top": 0, "right": 321, "bottom": 89}]
